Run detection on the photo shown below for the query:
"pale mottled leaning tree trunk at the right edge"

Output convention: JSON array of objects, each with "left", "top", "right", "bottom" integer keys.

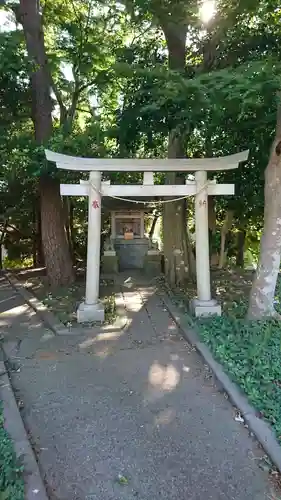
[{"left": 248, "top": 133, "right": 281, "bottom": 319}]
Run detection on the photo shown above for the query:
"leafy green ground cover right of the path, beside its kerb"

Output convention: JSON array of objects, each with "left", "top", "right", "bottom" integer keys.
[{"left": 195, "top": 280, "right": 281, "bottom": 443}]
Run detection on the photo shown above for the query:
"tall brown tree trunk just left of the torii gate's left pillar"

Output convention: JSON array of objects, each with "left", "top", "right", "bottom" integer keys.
[{"left": 15, "top": 0, "right": 73, "bottom": 286}]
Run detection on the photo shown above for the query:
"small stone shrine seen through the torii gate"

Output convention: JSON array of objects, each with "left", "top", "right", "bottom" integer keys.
[{"left": 102, "top": 203, "right": 161, "bottom": 275}]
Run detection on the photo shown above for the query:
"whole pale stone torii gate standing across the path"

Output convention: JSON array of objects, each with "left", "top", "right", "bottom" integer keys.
[{"left": 45, "top": 150, "right": 249, "bottom": 323}]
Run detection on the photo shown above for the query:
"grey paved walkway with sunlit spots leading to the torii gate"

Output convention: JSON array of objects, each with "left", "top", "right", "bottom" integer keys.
[{"left": 0, "top": 279, "right": 278, "bottom": 500}]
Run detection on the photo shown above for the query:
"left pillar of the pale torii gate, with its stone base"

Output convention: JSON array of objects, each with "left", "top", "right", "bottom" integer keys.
[{"left": 77, "top": 172, "right": 104, "bottom": 323}]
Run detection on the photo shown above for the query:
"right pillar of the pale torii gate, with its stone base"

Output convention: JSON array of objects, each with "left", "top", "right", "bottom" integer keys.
[{"left": 190, "top": 171, "right": 221, "bottom": 317}]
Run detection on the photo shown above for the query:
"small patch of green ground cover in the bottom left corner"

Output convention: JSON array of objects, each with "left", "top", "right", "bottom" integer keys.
[{"left": 0, "top": 406, "right": 24, "bottom": 500}]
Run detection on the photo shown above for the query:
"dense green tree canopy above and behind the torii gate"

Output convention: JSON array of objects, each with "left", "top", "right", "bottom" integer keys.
[{"left": 0, "top": 0, "right": 281, "bottom": 270}]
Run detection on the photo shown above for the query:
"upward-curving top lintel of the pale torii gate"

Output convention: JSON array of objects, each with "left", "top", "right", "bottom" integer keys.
[{"left": 45, "top": 149, "right": 249, "bottom": 172}]
